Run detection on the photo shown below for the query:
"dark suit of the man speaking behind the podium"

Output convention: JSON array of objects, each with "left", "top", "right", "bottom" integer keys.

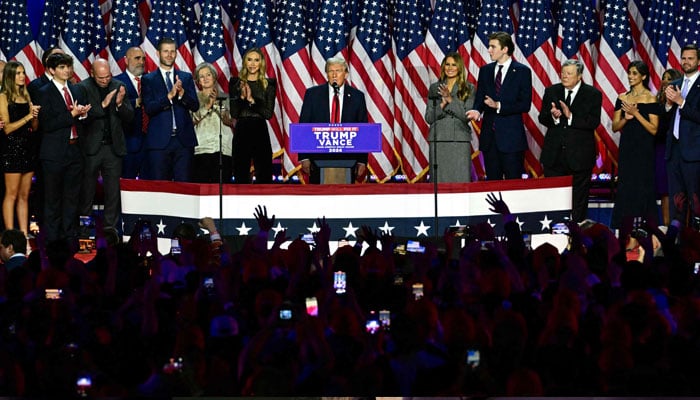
[{"left": 299, "top": 82, "right": 367, "bottom": 183}]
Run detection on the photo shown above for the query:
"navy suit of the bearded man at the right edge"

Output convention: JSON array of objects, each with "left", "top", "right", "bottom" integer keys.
[{"left": 666, "top": 77, "right": 700, "bottom": 221}]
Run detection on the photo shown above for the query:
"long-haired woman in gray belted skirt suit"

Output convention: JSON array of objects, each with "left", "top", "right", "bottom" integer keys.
[{"left": 425, "top": 53, "right": 474, "bottom": 182}]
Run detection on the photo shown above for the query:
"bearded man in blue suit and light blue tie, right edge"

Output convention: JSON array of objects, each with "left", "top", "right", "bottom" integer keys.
[{"left": 665, "top": 44, "right": 700, "bottom": 224}]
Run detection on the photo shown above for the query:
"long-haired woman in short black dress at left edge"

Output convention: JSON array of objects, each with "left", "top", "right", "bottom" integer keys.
[{"left": 0, "top": 61, "right": 39, "bottom": 236}]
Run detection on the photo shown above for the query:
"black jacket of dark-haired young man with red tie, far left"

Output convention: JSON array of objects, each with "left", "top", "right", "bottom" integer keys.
[{"left": 32, "top": 82, "right": 87, "bottom": 161}]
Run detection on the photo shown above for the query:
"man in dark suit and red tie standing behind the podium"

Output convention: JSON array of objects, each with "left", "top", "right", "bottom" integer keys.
[{"left": 299, "top": 57, "right": 367, "bottom": 184}]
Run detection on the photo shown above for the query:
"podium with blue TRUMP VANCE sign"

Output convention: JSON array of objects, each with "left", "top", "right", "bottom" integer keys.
[{"left": 289, "top": 123, "right": 382, "bottom": 184}]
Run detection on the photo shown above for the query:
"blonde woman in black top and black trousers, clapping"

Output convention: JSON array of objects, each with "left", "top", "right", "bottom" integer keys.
[{"left": 229, "top": 48, "right": 277, "bottom": 183}]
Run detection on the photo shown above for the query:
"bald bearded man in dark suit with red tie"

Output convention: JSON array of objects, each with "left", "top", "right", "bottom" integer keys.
[{"left": 114, "top": 47, "right": 147, "bottom": 179}]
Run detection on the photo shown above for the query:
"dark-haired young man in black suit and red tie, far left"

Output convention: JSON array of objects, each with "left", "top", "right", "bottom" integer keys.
[{"left": 32, "top": 53, "right": 90, "bottom": 244}]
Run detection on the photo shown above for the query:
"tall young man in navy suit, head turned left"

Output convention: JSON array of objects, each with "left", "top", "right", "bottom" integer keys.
[{"left": 467, "top": 32, "right": 532, "bottom": 180}]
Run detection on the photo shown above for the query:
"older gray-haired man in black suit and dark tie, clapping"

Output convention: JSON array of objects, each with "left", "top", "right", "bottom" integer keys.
[{"left": 539, "top": 60, "right": 603, "bottom": 222}]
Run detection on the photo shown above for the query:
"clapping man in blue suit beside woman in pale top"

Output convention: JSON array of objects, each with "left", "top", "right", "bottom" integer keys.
[{"left": 141, "top": 38, "right": 199, "bottom": 182}]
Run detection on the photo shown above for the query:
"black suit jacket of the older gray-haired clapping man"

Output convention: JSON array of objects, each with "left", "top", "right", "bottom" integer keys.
[{"left": 538, "top": 82, "right": 603, "bottom": 171}]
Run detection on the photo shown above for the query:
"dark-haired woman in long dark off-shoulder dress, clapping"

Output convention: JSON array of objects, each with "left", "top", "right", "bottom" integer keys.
[{"left": 612, "top": 61, "right": 659, "bottom": 228}]
